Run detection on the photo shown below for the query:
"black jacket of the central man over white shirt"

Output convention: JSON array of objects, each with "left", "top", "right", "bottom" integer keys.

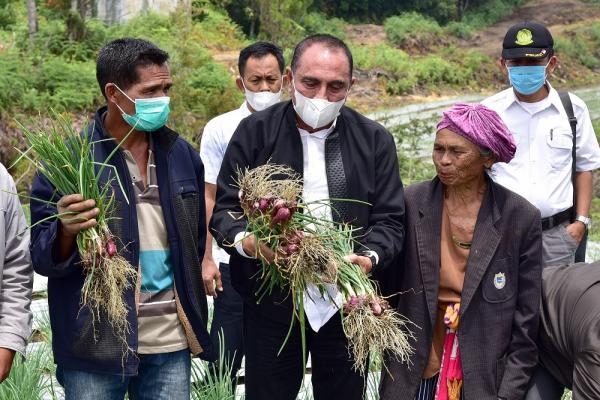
[{"left": 210, "top": 101, "right": 404, "bottom": 321}]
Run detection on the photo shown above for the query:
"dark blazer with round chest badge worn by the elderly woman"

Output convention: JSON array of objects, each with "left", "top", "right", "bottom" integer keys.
[{"left": 380, "top": 178, "right": 542, "bottom": 400}]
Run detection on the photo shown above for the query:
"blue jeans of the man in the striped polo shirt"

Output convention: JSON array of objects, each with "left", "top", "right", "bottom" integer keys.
[{"left": 56, "top": 349, "right": 191, "bottom": 400}]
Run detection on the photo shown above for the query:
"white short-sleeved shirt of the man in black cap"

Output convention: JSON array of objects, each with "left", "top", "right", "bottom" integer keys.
[{"left": 482, "top": 83, "right": 600, "bottom": 218}]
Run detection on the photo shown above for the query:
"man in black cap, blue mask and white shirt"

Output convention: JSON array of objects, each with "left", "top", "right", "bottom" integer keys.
[{"left": 482, "top": 21, "right": 600, "bottom": 266}]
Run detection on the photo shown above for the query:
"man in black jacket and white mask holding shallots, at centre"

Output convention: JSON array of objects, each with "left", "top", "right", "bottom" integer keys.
[{"left": 211, "top": 35, "right": 404, "bottom": 400}]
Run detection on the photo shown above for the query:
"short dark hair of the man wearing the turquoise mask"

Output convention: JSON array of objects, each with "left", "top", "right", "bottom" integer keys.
[{"left": 96, "top": 38, "right": 169, "bottom": 98}]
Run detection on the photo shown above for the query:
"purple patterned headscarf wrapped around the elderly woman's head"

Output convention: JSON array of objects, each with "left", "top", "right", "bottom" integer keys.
[{"left": 437, "top": 103, "right": 517, "bottom": 162}]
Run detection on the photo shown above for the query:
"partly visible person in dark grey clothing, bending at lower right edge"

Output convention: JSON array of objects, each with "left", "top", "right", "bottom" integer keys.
[{"left": 525, "top": 261, "right": 600, "bottom": 400}]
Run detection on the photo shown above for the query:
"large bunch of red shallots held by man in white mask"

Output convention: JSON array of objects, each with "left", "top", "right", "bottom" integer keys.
[{"left": 237, "top": 164, "right": 413, "bottom": 374}]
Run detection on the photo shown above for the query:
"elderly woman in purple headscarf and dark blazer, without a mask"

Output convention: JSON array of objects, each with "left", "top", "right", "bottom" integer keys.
[{"left": 380, "top": 103, "right": 542, "bottom": 400}]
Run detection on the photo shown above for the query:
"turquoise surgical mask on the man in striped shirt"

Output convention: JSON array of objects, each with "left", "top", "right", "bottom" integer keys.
[{"left": 115, "top": 85, "right": 171, "bottom": 132}]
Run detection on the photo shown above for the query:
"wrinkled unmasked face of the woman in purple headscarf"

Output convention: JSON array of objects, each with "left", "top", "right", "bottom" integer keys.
[{"left": 432, "top": 129, "right": 493, "bottom": 186}]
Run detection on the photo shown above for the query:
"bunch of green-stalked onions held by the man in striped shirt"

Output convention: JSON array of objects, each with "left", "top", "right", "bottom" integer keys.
[{"left": 17, "top": 116, "right": 137, "bottom": 355}]
